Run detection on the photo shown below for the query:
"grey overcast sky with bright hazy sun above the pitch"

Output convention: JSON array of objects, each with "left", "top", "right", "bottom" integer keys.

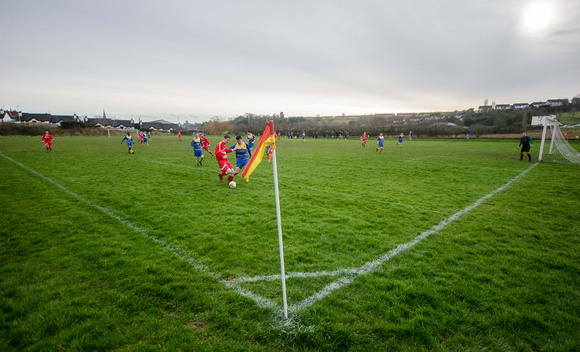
[{"left": 0, "top": 0, "right": 580, "bottom": 122}]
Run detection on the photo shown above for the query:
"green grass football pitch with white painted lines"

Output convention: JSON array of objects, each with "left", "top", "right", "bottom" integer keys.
[{"left": 0, "top": 136, "right": 580, "bottom": 351}]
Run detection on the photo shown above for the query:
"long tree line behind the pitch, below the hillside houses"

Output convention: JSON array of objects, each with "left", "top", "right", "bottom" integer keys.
[{"left": 203, "top": 97, "right": 580, "bottom": 137}]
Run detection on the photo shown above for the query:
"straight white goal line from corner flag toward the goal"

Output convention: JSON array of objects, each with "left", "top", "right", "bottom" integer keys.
[{"left": 288, "top": 162, "right": 538, "bottom": 313}]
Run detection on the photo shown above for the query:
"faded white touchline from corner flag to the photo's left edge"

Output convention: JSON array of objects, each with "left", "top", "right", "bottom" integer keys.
[{"left": 0, "top": 152, "right": 284, "bottom": 316}]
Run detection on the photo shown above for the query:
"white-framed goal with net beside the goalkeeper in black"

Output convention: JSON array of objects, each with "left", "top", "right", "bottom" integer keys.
[{"left": 532, "top": 115, "right": 580, "bottom": 164}]
